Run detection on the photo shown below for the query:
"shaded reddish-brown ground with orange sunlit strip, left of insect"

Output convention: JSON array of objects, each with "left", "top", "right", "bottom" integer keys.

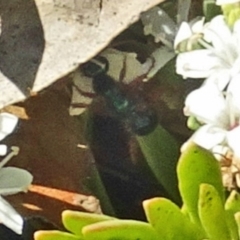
[{"left": 3, "top": 82, "right": 94, "bottom": 223}]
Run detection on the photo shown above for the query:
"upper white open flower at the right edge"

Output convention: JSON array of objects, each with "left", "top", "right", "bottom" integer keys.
[{"left": 177, "top": 15, "right": 240, "bottom": 90}]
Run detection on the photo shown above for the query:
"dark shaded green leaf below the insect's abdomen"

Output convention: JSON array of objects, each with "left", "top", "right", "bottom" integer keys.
[{"left": 136, "top": 125, "right": 180, "bottom": 203}]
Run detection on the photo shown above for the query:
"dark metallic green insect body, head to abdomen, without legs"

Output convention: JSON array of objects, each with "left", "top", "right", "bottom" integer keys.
[{"left": 82, "top": 57, "right": 158, "bottom": 135}]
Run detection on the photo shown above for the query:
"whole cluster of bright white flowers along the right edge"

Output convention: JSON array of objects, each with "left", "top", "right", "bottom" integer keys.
[{"left": 175, "top": 15, "right": 240, "bottom": 165}]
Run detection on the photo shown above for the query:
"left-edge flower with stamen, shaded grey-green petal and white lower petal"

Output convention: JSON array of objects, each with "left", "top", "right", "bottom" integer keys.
[{"left": 0, "top": 147, "right": 33, "bottom": 234}]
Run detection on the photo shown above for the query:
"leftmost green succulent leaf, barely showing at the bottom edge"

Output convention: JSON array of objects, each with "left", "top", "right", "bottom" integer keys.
[{"left": 34, "top": 230, "right": 83, "bottom": 240}]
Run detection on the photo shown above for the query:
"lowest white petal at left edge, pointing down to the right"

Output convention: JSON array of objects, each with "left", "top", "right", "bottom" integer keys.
[{"left": 0, "top": 196, "right": 23, "bottom": 234}]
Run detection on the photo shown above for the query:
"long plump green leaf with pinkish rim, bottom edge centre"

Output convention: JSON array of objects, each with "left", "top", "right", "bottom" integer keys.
[{"left": 82, "top": 220, "right": 159, "bottom": 240}]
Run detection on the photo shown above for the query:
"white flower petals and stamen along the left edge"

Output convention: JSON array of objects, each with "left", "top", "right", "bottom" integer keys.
[{"left": 0, "top": 113, "right": 33, "bottom": 234}]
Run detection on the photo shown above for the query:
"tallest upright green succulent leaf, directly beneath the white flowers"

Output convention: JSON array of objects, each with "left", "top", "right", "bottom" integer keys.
[{"left": 177, "top": 144, "right": 224, "bottom": 224}]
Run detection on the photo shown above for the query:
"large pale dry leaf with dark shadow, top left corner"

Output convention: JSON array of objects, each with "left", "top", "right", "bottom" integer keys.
[{"left": 0, "top": 0, "right": 163, "bottom": 109}]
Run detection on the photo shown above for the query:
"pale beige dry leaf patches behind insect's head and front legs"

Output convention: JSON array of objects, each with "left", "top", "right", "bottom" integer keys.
[{"left": 69, "top": 48, "right": 152, "bottom": 115}]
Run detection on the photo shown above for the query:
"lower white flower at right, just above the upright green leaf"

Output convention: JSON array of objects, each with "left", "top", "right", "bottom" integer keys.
[{"left": 184, "top": 84, "right": 240, "bottom": 161}]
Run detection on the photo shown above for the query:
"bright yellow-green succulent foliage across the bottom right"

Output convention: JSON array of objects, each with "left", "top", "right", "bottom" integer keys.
[{"left": 35, "top": 144, "right": 240, "bottom": 240}]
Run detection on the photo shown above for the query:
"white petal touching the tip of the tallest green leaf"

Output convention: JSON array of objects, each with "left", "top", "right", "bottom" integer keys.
[{"left": 190, "top": 124, "right": 226, "bottom": 150}]
